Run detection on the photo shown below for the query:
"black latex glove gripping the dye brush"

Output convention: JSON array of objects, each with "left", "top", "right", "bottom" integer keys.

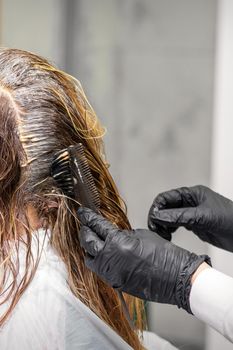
[{"left": 78, "top": 208, "right": 209, "bottom": 313}]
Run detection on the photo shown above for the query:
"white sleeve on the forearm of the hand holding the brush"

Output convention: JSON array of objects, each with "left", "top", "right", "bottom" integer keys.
[{"left": 190, "top": 268, "right": 233, "bottom": 342}]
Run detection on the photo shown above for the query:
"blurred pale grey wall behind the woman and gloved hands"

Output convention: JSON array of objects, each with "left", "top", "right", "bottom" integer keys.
[{"left": 0, "top": 0, "right": 233, "bottom": 350}]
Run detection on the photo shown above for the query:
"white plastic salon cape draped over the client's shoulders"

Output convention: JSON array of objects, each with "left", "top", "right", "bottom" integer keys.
[{"left": 0, "top": 229, "right": 176, "bottom": 350}]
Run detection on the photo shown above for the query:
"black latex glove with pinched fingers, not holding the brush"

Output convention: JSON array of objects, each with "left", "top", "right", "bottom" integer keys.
[{"left": 148, "top": 186, "right": 233, "bottom": 251}]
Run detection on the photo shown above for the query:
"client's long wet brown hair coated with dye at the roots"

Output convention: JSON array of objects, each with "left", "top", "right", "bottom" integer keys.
[{"left": 0, "top": 49, "right": 146, "bottom": 349}]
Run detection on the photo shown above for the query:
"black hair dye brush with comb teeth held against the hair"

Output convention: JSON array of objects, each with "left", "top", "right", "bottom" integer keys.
[{"left": 51, "top": 143, "right": 134, "bottom": 328}]
